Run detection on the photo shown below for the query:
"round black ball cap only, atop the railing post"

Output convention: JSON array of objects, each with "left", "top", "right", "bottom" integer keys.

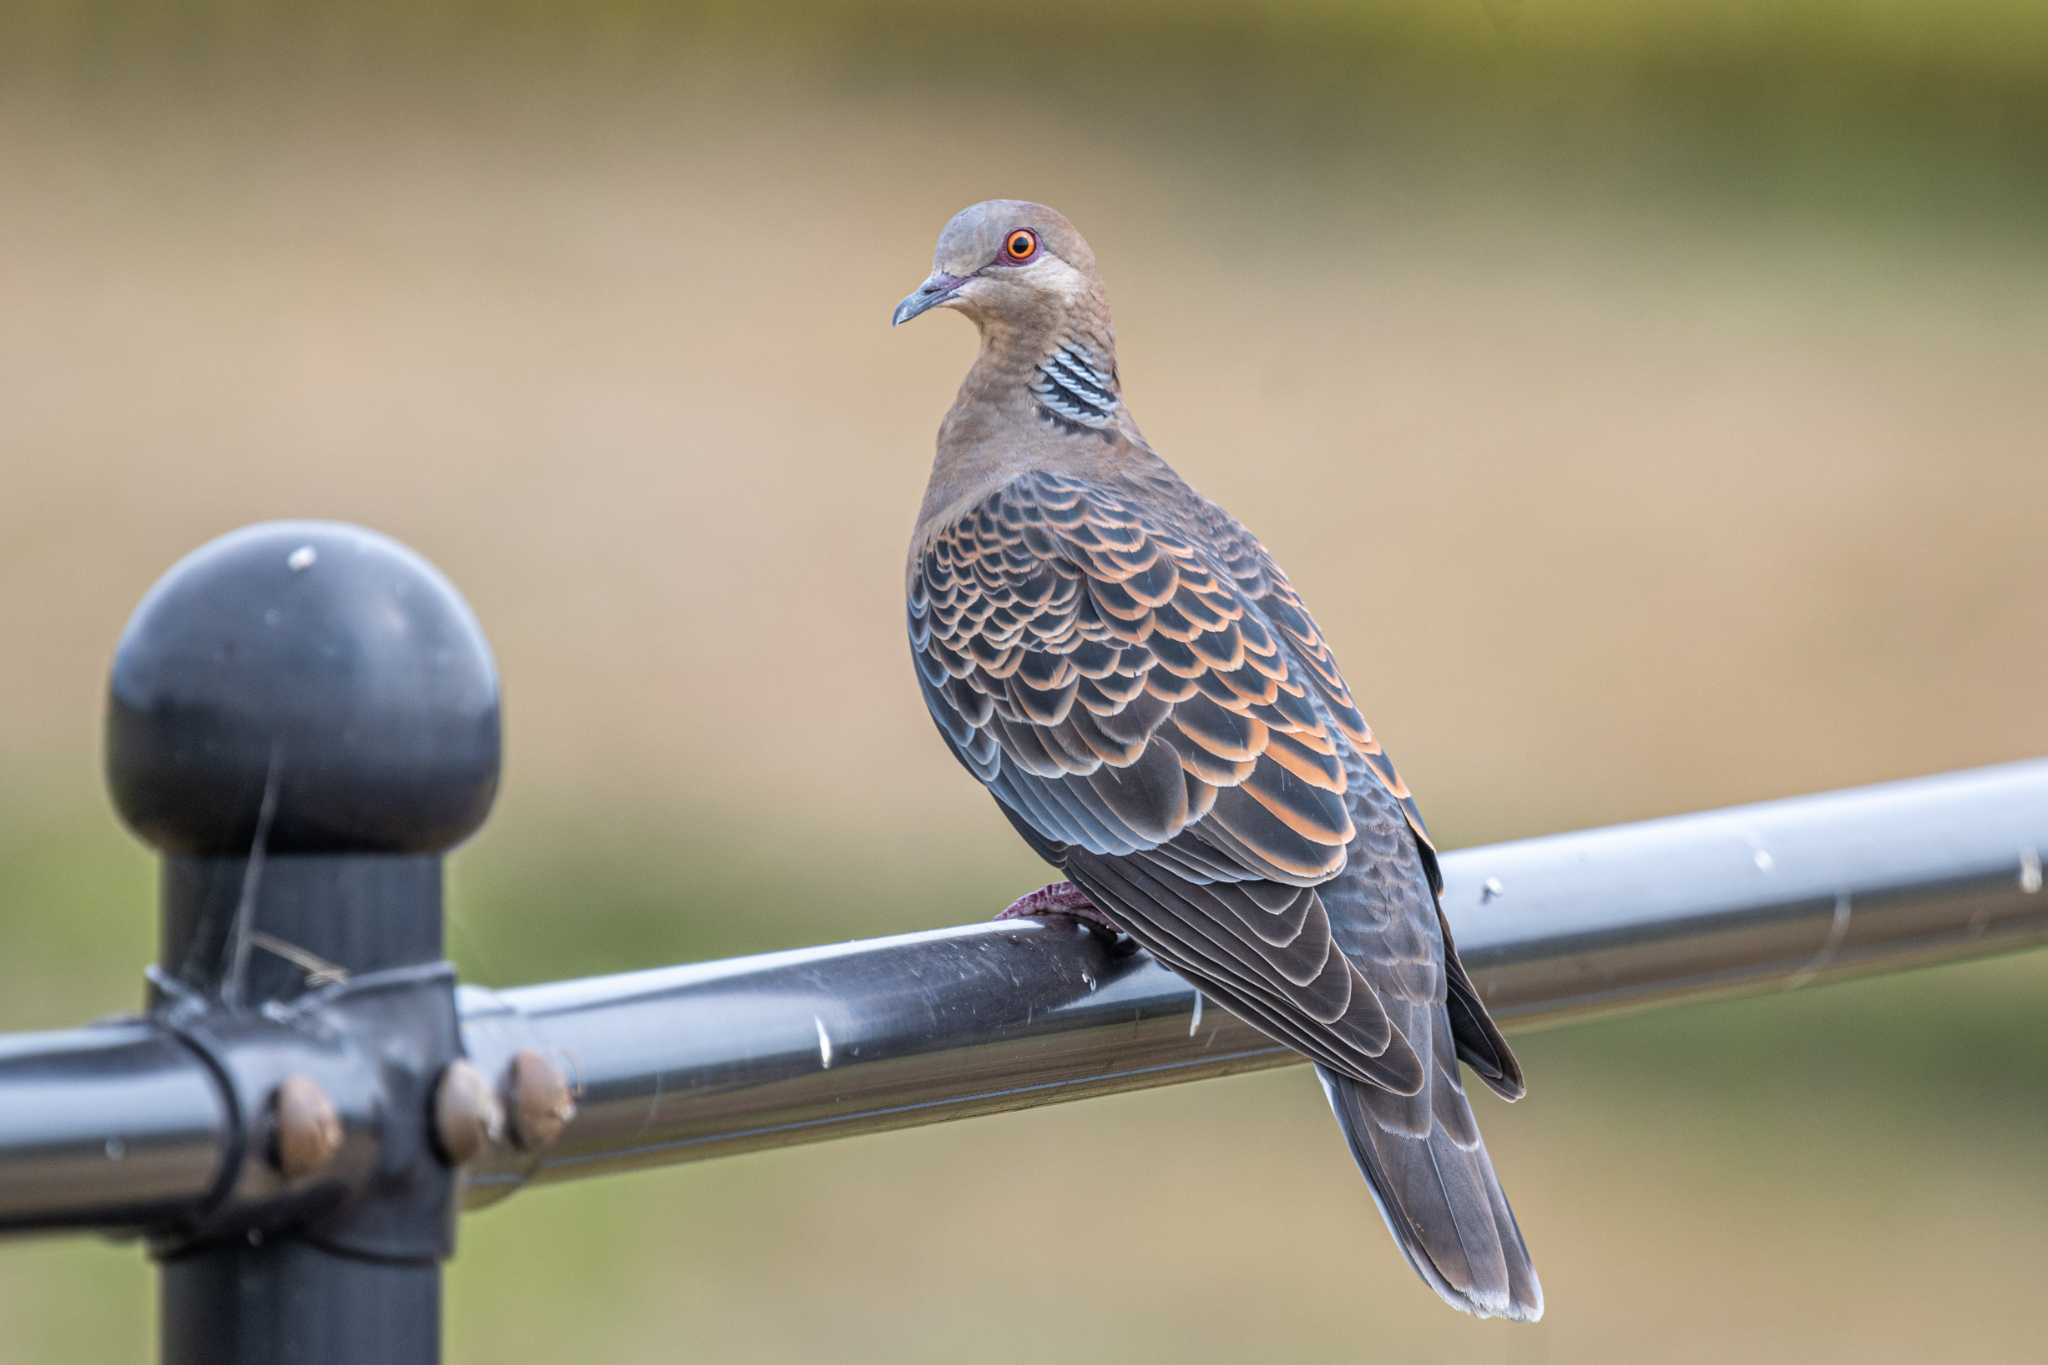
[{"left": 106, "top": 522, "right": 500, "bottom": 855}]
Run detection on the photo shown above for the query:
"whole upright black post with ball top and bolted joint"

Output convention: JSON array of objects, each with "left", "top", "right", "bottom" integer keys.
[{"left": 106, "top": 522, "right": 500, "bottom": 1365}]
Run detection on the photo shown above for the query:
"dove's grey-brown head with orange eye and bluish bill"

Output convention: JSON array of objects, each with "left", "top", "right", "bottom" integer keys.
[{"left": 891, "top": 199, "right": 1108, "bottom": 332}]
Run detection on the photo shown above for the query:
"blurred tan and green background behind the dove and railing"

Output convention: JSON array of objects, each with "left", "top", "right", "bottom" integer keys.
[{"left": 0, "top": 0, "right": 2048, "bottom": 1365}]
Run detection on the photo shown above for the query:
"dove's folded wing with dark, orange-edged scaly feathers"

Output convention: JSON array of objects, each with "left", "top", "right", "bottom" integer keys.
[{"left": 909, "top": 473, "right": 1425, "bottom": 1095}]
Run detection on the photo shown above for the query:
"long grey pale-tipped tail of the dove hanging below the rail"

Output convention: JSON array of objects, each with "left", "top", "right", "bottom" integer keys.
[{"left": 1315, "top": 1064, "right": 1542, "bottom": 1322}]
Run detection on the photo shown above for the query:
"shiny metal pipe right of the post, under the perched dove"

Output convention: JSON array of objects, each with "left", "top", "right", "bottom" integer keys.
[{"left": 461, "top": 761, "right": 2048, "bottom": 1205}]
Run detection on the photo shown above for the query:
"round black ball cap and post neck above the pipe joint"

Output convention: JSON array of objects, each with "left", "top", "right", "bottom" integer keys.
[{"left": 106, "top": 522, "right": 500, "bottom": 1001}]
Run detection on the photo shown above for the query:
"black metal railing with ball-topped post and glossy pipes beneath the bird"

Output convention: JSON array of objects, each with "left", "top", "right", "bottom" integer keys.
[{"left": 0, "top": 524, "right": 2048, "bottom": 1365}]
